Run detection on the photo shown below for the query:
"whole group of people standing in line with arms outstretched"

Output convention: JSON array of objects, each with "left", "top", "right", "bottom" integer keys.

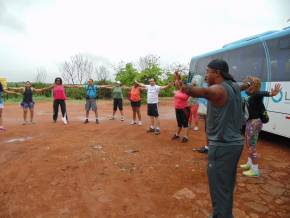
[{"left": 0, "top": 59, "right": 281, "bottom": 218}]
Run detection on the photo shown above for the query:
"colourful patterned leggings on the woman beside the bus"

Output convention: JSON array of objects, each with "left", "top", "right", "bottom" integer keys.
[{"left": 246, "top": 119, "right": 263, "bottom": 160}]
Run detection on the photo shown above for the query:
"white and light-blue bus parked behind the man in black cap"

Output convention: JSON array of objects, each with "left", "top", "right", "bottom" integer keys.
[{"left": 188, "top": 27, "right": 290, "bottom": 138}]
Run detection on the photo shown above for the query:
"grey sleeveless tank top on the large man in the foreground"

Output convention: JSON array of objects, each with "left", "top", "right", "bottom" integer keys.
[{"left": 206, "top": 81, "right": 243, "bottom": 146}]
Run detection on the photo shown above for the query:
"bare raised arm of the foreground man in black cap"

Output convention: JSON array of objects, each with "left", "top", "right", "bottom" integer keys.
[{"left": 182, "top": 85, "right": 228, "bottom": 106}]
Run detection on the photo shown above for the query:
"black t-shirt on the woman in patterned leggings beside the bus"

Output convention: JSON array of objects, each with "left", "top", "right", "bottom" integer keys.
[{"left": 248, "top": 91, "right": 270, "bottom": 119}]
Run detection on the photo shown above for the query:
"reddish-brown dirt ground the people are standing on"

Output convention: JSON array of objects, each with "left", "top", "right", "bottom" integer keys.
[{"left": 0, "top": 100, "right": 290, "bottom": 218}]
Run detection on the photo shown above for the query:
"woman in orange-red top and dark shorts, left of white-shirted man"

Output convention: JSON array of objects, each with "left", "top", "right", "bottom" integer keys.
[{"left": 129, "top": 83, "right": 142, "bottom": 126}]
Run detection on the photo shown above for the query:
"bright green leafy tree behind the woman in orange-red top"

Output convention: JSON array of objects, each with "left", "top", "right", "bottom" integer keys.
[{"left": 115, "top": 63, "right": 138, "bottom": 86}]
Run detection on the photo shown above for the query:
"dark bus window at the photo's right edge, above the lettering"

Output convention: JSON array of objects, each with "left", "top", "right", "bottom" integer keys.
[{"left": 267, "top": 36, "right": 290, "bottom": 81}]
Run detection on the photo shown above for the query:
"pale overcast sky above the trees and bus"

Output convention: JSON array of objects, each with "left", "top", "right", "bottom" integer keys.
[{"left": 0, "top": 0, "right": 290, "bottom": 81}]
